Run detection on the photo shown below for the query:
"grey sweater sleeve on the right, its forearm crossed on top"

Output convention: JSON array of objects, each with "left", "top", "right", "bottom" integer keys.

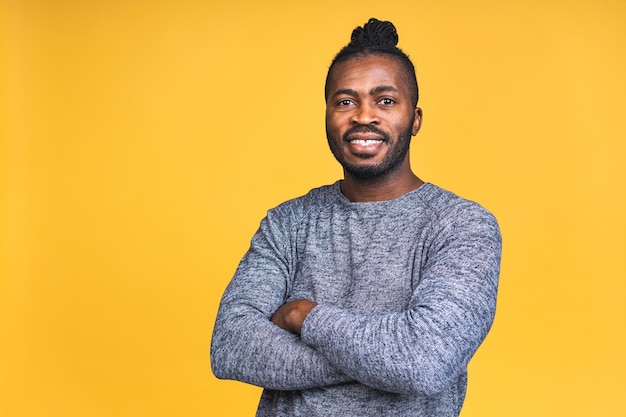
[{"left": 302, "top": 207, "right": 501, "bottom": 395}]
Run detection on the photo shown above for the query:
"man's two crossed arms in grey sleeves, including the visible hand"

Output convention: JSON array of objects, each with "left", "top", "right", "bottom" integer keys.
[{"left": 211, "top": 206, "right": 501, "bottom": 395}]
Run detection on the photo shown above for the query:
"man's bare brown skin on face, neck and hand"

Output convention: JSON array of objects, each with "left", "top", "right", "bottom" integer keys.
[{"left": 271, "top": 55, "right": 424, "bottom": 334}]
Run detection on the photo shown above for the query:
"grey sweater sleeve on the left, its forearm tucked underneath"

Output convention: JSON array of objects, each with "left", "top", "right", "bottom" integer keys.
[{"left": 211, "top": 206, "right": 351, "bottom": 390}]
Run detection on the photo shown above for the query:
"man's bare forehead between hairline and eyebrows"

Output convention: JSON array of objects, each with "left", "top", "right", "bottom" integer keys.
[{"left": 328, "top": 55, "right": 409, "bottom": 96}]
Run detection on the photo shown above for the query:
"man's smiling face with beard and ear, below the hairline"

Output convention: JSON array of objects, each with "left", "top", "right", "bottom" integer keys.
[{"left": 326, "top": 55, "right": 421, "bottom": 179}]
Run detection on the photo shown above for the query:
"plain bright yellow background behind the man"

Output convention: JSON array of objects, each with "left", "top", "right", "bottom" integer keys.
[{"left": 0, "top": 0, "right": 626, "bottom": 417}]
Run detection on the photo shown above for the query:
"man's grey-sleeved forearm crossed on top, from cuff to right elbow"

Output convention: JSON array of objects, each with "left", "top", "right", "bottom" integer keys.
[{"left": 302, "top": 300, "right": 486, "bottom": 395}]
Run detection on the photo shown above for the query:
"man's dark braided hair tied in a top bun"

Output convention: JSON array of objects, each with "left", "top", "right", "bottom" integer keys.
[{"left": 324, "top": 18, "right": 419, "bottom": 106}]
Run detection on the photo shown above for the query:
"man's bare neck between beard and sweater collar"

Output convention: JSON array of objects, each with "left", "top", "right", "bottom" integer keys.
[{"left": 341, "top": 170, "right": 424, "bottom": 202}]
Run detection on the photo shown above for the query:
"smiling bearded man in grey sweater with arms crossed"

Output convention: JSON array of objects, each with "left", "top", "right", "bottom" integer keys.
[{"left": 211, "top": 19, "right": 501, "bottom": 417}]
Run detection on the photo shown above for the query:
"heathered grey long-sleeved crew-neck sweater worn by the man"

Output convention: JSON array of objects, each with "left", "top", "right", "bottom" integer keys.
[{"left": 211, "top": 182, "right": 501, "bottom": 417}]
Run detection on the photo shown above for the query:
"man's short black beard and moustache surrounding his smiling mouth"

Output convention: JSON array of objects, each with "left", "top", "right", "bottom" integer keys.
[{"left": 326, "top": 120, "right": 413, "bottom": 180}]
